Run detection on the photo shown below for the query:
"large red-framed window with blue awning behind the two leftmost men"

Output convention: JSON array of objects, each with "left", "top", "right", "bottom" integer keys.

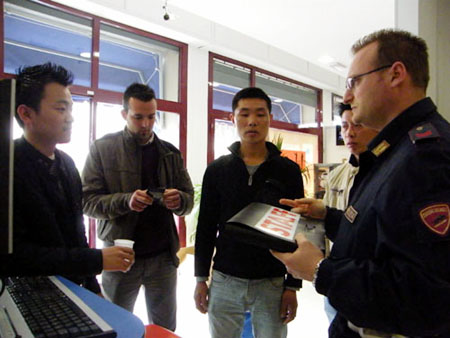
[{"left": 0, "top": 0, "right": 187, "bottom": 246}]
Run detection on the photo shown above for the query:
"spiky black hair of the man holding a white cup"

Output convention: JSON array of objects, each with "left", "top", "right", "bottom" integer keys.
[{"left": 16, "top": 62, "right": 73, "bottom": 127}]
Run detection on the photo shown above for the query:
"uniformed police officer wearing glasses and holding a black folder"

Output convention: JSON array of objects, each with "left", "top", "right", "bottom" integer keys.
[{"left": 274, "top": 30, "right": 450, "bottom": 338}]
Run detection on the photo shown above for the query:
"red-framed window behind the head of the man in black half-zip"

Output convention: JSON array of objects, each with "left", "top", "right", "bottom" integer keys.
[{"left": 208, "top": 53, "right": 323, "bottom": 168}]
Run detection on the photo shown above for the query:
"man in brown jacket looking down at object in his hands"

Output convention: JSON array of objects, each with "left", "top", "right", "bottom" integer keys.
[{"left": 82, "top": 83, "right": 193, "bottom": 331}]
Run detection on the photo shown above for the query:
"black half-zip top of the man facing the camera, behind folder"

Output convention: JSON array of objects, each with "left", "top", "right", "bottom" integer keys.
[{"left": 195, "top": 142, "right": 304, "bottom": 287}]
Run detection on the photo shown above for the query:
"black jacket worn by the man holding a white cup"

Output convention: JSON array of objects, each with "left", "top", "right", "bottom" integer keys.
[{"left": 9, "top": 138, "right": 103, "bottom": 293}]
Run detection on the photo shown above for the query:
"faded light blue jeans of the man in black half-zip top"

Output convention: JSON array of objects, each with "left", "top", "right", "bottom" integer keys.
[{"left": 208, "top": 270, "right": 287, "bottom": 338}]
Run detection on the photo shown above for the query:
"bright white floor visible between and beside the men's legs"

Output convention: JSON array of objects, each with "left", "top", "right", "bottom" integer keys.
[{"left": 134, "top": 255, "right": 328, "bottom": 338}]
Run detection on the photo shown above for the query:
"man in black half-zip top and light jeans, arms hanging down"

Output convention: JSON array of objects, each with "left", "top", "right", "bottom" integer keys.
[{"left": 194, "top": 88, "right": 304, "bottom": 338}]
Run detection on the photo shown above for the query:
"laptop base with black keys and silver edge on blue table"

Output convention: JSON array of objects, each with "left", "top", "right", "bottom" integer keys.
[{"left": 0, "top": 276, "right": 117, "bottom": 338}]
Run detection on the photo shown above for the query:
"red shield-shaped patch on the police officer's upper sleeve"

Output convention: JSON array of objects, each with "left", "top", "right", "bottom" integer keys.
[{"left": 419, "top": 203, "right": 450, "bottom": 236}]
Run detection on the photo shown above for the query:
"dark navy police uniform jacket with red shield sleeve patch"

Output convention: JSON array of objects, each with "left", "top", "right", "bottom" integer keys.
[{"left": 315, "top": 98, "right": 450, "bottom": 338}]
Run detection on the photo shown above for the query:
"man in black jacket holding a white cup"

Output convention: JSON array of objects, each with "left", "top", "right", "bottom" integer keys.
[{"left": 2, "top": 63, "right": 134, "bottom": 293}]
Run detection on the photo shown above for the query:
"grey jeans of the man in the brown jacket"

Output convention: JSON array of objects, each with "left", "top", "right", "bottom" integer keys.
[{"left": 102, "top": 252, "right": 177, "bottom": 331}]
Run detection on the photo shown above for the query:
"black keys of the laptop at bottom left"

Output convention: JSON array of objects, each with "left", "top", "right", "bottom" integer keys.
[{"left": 7, "top": 277, "right": 111, "bottom": 338}]
